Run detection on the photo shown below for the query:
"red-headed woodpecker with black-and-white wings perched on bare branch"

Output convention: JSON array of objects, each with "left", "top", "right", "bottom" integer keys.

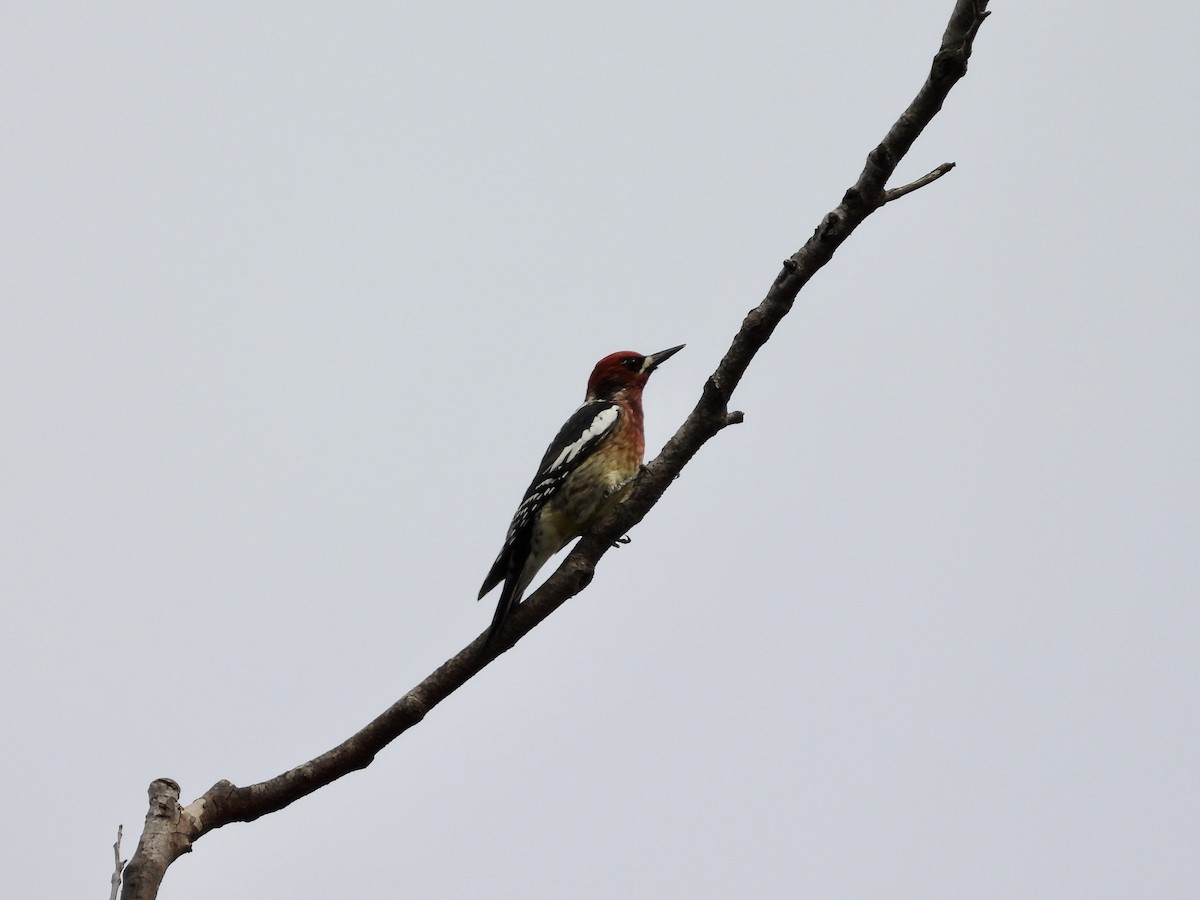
[{"left": 479, "top": 344, "right": 685, "bottom": 647}]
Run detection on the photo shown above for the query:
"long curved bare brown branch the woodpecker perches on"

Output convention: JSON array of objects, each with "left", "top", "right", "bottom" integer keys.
[{"left": 122, "top": 0, "right": 988, "bottom": 900}]
